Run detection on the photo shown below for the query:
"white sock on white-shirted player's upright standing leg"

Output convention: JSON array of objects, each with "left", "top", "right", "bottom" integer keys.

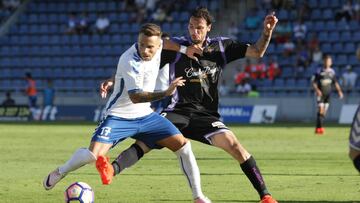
[{"left": 175, "top": 142, "right": 204, "bottom": 199}]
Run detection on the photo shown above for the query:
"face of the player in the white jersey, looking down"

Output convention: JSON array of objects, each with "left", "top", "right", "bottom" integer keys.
[{"left": 138, "top": 33, "right": 161, "bottom": 61}]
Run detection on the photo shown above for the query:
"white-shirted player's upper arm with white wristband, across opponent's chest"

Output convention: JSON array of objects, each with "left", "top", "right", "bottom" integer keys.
[{"left": 163, "top": 39, "right": 203, "bottom": 60}]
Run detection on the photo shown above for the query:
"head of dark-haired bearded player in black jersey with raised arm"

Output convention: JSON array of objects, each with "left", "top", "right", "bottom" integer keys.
[{"left": 188, "top": 7, "right": 213, "bottom": 44}]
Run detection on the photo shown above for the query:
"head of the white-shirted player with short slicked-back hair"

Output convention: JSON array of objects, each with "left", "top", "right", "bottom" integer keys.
[{"left": 137, "top": 23, "right": 162, "bottom": 61}]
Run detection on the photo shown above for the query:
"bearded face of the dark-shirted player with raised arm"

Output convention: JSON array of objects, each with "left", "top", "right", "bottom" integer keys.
[{"left": 188, "top": 17, "right": 211, "bottom": 44}]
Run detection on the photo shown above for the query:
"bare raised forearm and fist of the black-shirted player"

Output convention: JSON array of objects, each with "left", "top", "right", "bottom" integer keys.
[{"left": 245, "top": 12, "right": 278, "bottom": 58}]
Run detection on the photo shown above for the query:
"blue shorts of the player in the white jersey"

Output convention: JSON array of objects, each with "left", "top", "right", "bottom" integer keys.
[{"left": 91, "top": 113, "right": 181, "bottom": 149}]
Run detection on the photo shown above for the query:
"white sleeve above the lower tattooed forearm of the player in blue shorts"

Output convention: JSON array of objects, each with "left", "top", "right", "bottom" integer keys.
[{"left": 118, "top": 53, "right": 144, "bottom": 93}]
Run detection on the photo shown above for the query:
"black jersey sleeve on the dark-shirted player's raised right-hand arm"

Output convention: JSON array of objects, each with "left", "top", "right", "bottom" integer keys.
[{"left": 222, "top": 39, "right": 249, "bottom": 63}]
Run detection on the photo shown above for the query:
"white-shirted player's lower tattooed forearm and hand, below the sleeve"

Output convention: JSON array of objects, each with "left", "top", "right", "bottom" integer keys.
[{"left": 129, "top": 77, "right": 185, "bottom": 104}]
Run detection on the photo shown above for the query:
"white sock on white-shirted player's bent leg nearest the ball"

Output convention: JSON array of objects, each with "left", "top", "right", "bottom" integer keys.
[{"left": 59, "top": 148, "right": 96, "bottom": 174}]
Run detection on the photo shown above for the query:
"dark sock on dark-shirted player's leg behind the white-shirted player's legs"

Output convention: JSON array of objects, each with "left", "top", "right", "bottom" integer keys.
[{"left": 112, "top": 144, "right": 144, "bottom": 176}]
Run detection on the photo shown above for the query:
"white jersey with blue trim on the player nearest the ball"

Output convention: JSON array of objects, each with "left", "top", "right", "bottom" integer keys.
[{"left": 105, "top": 44, "right": 162, "bottom": 119}]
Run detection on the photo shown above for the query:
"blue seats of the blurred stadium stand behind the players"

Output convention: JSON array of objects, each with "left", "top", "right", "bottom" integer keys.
[{"left": 0, "top": 0, "right": 360, "bottom": 100}]
